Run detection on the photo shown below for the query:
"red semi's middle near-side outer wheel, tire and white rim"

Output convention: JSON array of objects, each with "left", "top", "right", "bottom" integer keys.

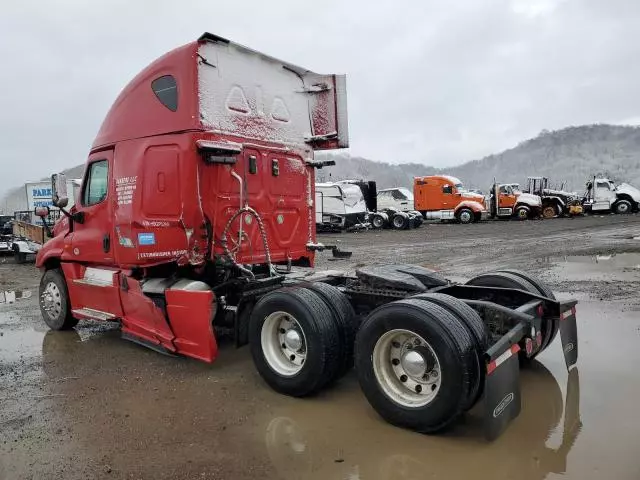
[{"left": 249, "top": 287, "right": 340, "bottom": 397}]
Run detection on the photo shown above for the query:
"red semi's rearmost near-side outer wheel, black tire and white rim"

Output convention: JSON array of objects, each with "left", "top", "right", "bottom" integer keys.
[{"left": 355, "top": 298, "right": 477, "bottom": 433}]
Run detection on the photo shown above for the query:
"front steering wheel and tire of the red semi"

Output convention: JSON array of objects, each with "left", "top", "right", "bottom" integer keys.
[{"left": 38, "top": 268, "right": 78, "bottom": 330}]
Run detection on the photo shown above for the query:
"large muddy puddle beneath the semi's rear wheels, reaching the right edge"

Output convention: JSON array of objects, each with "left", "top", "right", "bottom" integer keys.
[{"left": 256, "top": 302, "right": 640, "bottom": 480}]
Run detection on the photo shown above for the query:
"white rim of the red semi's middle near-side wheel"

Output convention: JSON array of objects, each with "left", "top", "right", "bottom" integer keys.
[{"left": 260, "top": 312, "right": 307, "bottom": 377}]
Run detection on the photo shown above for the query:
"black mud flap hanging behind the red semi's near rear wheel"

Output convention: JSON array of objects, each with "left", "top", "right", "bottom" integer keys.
[{"left": 484, "top": 345, "right": 522, "bottom": 441}]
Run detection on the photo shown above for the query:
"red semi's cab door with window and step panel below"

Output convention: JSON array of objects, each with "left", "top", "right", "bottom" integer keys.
[{"left": 63, "top": 150, "right": 122, "bottom": 320}]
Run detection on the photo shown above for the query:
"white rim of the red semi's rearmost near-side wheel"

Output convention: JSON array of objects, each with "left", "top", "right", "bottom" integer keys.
[{"left": 372, "top": 329, "right": 442, "bottom": 408}]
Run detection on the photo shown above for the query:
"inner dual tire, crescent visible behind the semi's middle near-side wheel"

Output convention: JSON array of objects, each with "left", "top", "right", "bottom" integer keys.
[{"left": 306, "top": 282, "right": 356, "bottom": 383}]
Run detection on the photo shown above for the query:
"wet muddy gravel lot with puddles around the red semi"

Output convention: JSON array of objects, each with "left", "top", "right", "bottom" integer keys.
[{"left": 0, "top": 215, "right": 640, "bottom": 480}]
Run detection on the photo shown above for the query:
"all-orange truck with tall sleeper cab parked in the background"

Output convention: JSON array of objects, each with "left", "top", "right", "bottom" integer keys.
[{"left": 413, "top": 175, "right": 488, "bottom": 223}]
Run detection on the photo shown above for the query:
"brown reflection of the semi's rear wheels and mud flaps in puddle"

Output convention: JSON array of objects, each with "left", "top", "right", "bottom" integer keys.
[{"left": 265, "top": 364, "right": 582, "bottom": 480}]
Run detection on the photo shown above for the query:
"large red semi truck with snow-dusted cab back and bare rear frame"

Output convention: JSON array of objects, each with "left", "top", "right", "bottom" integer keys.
[{"left": 37, "top": 33, "right": 577, "bottom": 438}]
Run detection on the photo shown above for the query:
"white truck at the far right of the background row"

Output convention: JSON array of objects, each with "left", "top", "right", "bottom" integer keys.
[{"left": 582, "top": 177, "right": 640, "bottom": 214}]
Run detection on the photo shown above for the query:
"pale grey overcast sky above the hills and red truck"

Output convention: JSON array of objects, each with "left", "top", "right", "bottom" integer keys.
[{"left": 0, "top": 0, "right": 640, "bottom": 195}]
